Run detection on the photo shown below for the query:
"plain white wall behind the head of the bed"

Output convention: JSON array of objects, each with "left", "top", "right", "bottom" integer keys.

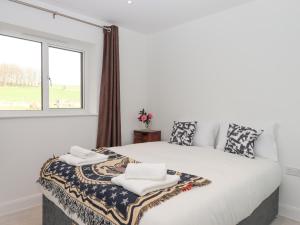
[{"left": 149, "top": 0, "right": 300, "bottom": 220}]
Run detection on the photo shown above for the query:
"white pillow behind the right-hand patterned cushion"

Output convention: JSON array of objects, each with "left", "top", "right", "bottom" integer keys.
[{"left": 216, "top": 122, "right": 278, "bottom": 162}]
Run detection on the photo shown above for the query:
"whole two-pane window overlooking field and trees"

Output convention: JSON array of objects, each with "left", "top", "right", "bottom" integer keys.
[{"left": 0, "top": 35, "right": 84, "bottom": 112}]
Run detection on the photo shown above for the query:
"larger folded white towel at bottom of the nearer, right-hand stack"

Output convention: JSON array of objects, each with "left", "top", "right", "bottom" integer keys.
[{"left": 111, "top": 174, "right": 180, "bottom": 196}]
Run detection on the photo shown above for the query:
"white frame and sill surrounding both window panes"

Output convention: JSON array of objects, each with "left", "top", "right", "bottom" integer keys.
[{"left": 0, "top": 30, "right": 89, "bottom": 119}]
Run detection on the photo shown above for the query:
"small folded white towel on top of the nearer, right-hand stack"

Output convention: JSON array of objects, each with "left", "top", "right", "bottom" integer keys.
[{"left": 125, "top": 163, "right": 167, "bottom": 180}]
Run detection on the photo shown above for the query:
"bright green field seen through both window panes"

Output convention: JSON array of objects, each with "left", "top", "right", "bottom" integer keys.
[{"left": 0, "top": 85, "right": 81, "bottom": 110}]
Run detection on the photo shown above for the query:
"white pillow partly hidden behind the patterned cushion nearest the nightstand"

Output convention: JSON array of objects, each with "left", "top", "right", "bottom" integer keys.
[{"left": 193, "top": 121, "right": 219, "bottom": 148}]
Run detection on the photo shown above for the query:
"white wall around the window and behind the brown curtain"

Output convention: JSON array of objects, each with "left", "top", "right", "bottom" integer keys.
[{"left": 0, "top": 1, "right": 147, "bottom": 215}]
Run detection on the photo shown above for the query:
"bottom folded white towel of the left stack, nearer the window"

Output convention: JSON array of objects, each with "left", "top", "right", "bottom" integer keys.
[{"left": 59, "top": 153, "right": 108, "bottom": 166}]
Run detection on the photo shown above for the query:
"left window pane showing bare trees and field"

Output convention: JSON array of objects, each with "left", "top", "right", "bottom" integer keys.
[{"left": 0, "top": 35, "right": 42, "bottom": 110}]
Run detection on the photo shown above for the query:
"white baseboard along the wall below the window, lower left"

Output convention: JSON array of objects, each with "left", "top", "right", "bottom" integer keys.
[{"left": 0, "top": 193, "right": 42, "bottom": 217}]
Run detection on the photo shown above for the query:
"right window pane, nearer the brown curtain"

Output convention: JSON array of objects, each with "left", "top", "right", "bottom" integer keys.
[{"left": 49, "top": 47, "right": 82, "bottom": 109}]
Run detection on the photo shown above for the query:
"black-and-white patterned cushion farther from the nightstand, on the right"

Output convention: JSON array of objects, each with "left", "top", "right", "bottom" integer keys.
[{"left": 225, "top": 123, "right": 263, "bottom": 159}]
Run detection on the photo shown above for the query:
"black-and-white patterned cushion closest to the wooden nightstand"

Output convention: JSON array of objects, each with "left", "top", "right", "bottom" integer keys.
[{"left": 169, "top": 121, "right": 197, "bottom": 146}]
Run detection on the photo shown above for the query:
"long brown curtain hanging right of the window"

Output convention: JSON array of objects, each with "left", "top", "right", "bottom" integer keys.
[{"left": 97, "top": 26, "right": 121, "bottom": 148}]
